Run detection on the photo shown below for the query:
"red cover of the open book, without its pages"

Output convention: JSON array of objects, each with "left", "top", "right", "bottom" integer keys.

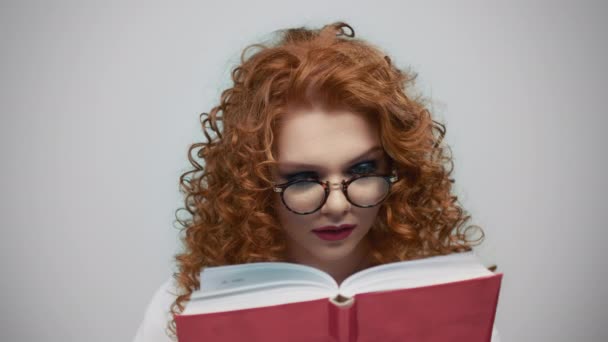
[{"left": 175, "top": 274, "right": 502, "bottom": 342}]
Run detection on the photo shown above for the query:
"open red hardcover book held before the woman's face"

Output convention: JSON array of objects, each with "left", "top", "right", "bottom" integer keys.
[{"left": 175, "top": 252, "right": 502, "bottom": 342}]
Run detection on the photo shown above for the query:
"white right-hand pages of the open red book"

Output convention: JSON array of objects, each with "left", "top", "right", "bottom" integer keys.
[{"left": 339, "top": 252, "right": 493, "bottom": 297}]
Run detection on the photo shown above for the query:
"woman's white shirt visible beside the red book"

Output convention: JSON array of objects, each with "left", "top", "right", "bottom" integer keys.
[{"left": 133, "top": 278, "right": 500, "bottom": 342}]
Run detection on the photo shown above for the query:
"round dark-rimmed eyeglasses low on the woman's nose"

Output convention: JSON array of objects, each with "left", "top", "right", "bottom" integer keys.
[{"left": 273, "top": 172, "right": 398, "bottom": 215}]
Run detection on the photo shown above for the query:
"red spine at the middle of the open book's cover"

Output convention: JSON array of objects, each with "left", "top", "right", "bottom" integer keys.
[{"left": 327, "top": 298, "right": 357, "bottom": 342}]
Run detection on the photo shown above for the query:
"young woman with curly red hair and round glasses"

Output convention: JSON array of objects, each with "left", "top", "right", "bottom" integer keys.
[{"left": 135, "top": 23, "right": 497, "bottom": 342}]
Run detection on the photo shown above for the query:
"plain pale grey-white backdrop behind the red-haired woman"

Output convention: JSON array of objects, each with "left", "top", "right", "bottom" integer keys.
[{"left": 0, "top": 0, "right": 608, "bottom": 342}]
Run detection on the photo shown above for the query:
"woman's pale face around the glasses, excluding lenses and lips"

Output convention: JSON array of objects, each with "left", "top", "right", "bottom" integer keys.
[{"left": 275, "top": 108, "right": 389, "bottom": 265}]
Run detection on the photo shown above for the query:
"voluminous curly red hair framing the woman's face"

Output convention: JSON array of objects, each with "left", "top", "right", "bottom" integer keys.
[{"left": 169, "top": 23, "right": 483, "bottom": 340}]
